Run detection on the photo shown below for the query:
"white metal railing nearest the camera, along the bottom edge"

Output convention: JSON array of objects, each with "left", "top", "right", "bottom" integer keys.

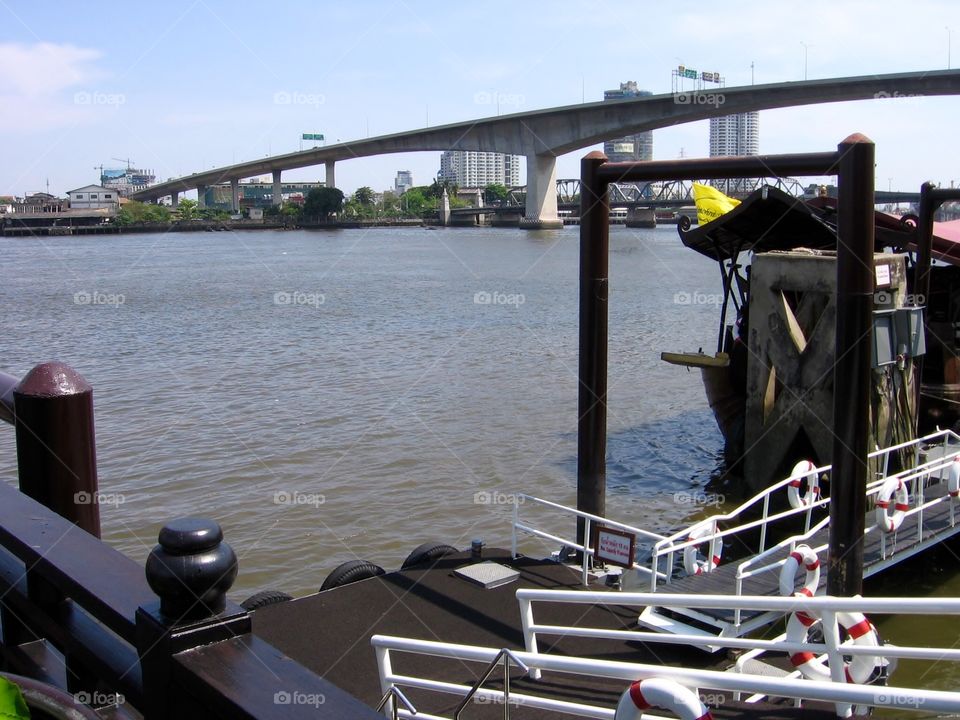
[{"left": 371, "top": 608, "right": 960, "bottom": 720}]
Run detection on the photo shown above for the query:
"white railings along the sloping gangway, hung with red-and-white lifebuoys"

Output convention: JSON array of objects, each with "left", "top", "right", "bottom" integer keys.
[{"left": 647, "top": 430, "right": 960, "bottom": 593}]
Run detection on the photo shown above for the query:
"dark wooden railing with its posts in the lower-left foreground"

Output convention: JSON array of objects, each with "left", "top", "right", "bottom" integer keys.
[{"left": 0, "top": 363, "right": 382, "bottom": 720}]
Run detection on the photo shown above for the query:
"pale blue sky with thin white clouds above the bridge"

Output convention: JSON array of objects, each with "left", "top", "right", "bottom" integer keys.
[{"left": 0, "top": 0, "right": 960, "bottom": 195}]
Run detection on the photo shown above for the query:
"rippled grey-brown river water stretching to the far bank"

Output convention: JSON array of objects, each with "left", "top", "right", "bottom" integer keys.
[{"left": 0, "top": 226, "right": 957, "bottom": 696}]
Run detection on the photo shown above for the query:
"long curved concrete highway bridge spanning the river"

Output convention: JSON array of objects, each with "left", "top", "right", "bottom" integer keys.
[{"left": 132, "top": 70, "right": 960, "bottom": 228}]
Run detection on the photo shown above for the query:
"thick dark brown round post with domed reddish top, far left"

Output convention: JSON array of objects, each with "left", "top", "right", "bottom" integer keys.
[{"left": 13, "top": 362, "right": 100, "bottom": 537}]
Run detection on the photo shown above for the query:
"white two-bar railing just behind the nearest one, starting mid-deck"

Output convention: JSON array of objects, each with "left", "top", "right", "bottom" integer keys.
[{"left": 516, "top": 589, "right": 960, "bottom": 716}]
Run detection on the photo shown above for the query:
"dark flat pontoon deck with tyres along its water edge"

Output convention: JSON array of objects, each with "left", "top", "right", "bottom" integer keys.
[{"left": 253, "top": 549, "right": 835, "bottom": 720}]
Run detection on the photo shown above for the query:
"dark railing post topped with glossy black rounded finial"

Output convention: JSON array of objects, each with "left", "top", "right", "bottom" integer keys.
[{"left": 136, "top": 518, "right": 251, "bottom": 720}]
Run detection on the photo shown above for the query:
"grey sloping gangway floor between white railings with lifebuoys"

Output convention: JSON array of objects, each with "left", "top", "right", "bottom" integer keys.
[{"left": 657, "top": 492, "right": 960, "bottom": 623}]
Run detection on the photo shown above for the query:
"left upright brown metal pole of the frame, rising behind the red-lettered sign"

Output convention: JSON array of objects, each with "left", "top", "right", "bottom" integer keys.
[{"left": 577, "top": 151, "right": 610, "bottom": 544}]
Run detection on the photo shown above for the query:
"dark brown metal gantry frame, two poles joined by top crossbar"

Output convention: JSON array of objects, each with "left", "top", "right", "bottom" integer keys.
[{"left": 577, "top": 134, "right": 875, "bottom": 595}]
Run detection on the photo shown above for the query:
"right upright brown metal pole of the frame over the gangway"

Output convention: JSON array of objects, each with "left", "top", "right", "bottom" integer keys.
[{"left": 827, "top": 134, "right": 875, "bottom": 596}]
